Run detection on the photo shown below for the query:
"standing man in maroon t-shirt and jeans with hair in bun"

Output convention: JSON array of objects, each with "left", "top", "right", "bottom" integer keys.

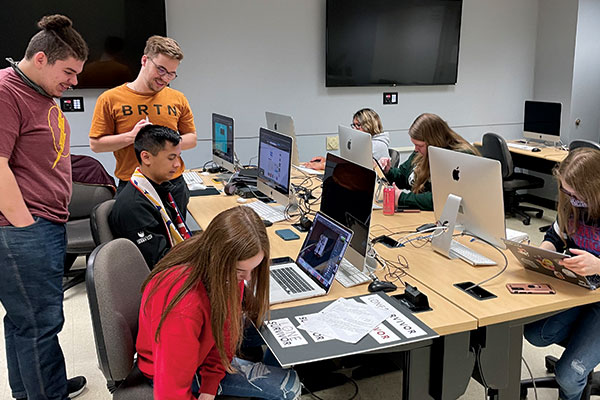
[{"left": 0, "top": 15, "right": 88, "bottom": 400}]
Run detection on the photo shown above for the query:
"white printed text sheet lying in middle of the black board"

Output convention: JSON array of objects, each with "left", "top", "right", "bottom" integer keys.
[{"left": 298, "top": 298, "right": 391, "bottom": 343}]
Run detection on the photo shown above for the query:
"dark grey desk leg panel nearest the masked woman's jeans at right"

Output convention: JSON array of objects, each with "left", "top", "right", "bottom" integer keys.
[{"left": 474, "top": 323, "right": 523, "bottom": 400}]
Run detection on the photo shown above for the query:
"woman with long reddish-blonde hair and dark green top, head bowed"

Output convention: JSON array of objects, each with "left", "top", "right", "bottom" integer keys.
[{"left": 380, "top": 114, "right": 479, "bottom": 211}]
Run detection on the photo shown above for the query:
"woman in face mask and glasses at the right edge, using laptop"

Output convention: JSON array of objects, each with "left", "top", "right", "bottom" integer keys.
[{"left": 524, "top": 148, "right": 600, "bottom": 400}]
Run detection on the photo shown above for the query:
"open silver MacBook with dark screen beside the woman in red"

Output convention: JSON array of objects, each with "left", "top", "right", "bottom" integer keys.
[{"left": 270, "top": 212, "right": 352, "bottom": 304}]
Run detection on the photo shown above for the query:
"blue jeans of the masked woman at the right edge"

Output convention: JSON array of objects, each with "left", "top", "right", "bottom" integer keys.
[{"left": 524, "top": 303, "right": 600, "bottom": 400}]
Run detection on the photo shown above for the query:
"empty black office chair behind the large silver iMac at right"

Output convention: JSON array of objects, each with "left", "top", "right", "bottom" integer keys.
[{"left": 481, "top": 133, "right": 544, "bottom": 225}]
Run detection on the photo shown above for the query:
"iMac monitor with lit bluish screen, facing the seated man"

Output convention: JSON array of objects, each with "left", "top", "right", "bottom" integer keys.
[{"left": 256, "top": 128, "right": 294, "bottom": 205}]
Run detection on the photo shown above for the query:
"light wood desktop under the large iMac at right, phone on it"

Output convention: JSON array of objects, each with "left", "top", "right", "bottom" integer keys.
[{"left": 372, "top": 212, "right": 600, "bottom": 326}]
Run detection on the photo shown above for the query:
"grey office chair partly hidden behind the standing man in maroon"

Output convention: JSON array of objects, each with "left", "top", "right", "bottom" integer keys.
[{"left": 63, "top": 182, "right": 114, "bottom": 291}]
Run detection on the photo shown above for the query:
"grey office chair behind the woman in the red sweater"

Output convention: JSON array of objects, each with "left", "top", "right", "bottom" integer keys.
[{"left": 85, "top": 239, "right": 248, "bottom": 400}]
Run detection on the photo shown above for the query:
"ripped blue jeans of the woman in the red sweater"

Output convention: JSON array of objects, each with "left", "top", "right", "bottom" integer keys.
[{"left": 192, "top": 357, "right": 302, "bottom": 400}]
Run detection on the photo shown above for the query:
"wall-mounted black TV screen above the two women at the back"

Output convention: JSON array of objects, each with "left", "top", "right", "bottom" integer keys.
[{"left": 326, "top": 0, "right": 462, "bottom": 87}]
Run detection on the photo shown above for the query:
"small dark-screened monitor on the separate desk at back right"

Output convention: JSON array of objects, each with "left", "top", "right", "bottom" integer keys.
[{"left": 523, "top": 100, "right": 562, "bottom": 143}]
